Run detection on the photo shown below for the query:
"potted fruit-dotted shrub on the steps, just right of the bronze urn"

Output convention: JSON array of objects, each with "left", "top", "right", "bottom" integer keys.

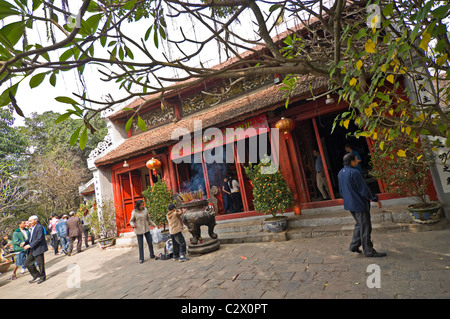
[{"left": 244, "top": 156, "right": 294, "bottom": 232}]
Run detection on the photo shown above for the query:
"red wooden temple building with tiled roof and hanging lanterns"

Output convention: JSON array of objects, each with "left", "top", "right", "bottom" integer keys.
[{"left": 88, "top": 26, "right": 442, "bottom": 234}]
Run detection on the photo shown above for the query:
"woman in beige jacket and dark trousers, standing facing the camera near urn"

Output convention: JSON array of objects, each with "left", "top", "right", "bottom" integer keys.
[{"left": 130, "top": 199, "right": 156, "bottom": 264}]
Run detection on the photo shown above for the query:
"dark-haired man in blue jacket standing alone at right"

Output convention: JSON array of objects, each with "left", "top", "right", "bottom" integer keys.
[{"left": 338, "top": 153, "right": 386, "bottom": 257}]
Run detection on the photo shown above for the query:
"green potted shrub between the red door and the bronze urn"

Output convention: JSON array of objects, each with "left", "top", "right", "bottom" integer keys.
[{"left": 142, "top": 175, "right": 175, "bottom": 241}]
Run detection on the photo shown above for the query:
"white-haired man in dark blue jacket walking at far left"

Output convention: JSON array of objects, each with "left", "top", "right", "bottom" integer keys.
[{"left": 21, "top": 215, "right": 48, "bottom": 284}]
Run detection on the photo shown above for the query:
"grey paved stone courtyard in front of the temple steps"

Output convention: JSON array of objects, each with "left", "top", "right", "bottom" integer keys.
[{"left": 0, "top": 227, "right": 450, "bottom": 300}]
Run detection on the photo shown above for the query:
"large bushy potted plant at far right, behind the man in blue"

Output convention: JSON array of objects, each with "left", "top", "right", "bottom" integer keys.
[{"left": 371, "top": 136, "right": 442, "bottom": 223}]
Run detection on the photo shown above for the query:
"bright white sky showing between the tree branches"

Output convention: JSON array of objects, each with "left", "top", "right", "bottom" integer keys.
[{"left": 7, "top": 2, "right": 292, "bottom": 126}]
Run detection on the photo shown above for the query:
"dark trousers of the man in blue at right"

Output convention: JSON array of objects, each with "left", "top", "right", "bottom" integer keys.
[{"left": 350, "top": 211, "right": 373, "bottom": 255}]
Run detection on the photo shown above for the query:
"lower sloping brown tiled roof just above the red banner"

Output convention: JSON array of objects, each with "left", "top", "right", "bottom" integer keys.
[{"left": 95, "top": 76, "right": 328, "bottom": 166}]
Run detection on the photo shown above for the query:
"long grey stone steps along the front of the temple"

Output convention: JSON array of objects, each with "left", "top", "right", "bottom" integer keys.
[{"left": 116, "top": 205, "right": 447, "bottom": 248}]
